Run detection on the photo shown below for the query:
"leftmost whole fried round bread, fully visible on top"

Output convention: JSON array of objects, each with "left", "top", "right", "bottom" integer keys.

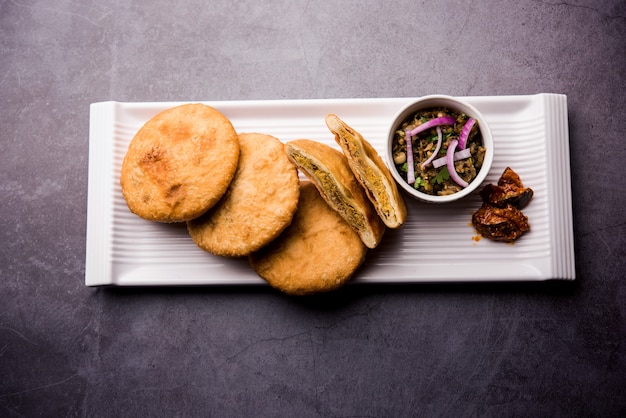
[{"left": 120, "top": 103, "right": 239, "bottom": 222}]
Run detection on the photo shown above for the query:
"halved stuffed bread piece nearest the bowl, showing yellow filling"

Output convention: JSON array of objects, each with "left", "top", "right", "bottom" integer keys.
[{"left": 326, "top": 114, "right": 407, "bottom": 228}]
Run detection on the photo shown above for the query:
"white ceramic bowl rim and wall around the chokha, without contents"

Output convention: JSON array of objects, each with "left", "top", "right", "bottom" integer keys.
[{"left": 386, "top": 95, "right": 494, "bottom": 203}]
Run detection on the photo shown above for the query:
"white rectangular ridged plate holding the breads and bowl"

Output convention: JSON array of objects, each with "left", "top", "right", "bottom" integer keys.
[{"left": 85, "top": 94, "right": 575, "bottom": 286}]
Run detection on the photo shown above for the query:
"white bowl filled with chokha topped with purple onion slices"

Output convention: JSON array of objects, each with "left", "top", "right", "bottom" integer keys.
[{"left": 387, "top": 95, "right": 493, "bottom": 203}]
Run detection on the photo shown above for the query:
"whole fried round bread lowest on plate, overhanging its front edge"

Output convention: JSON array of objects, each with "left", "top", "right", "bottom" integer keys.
[{"left": 249, "top": 181, "right": 367, "bottom": 295}]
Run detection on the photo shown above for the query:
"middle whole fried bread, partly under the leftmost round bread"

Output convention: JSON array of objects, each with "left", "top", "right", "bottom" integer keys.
[{"left": 187, "top": 133, "right": 300, "bottom": 257}]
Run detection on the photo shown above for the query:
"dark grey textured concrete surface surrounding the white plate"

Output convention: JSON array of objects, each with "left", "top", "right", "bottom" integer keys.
[{"left": 0, "top": 0, "right": 626, "bottom": 417}]
